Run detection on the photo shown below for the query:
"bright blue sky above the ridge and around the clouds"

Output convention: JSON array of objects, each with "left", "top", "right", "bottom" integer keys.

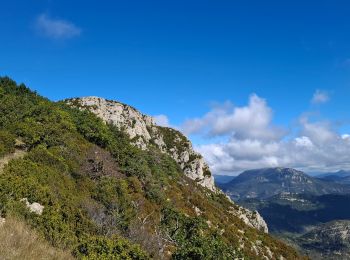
[{"left": 0, "top": 0, "right": 350, "bottom": 173}]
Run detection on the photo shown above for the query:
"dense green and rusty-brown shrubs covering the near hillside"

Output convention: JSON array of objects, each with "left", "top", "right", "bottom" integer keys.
[{"left": 0, "top": 78, "right": 298, "bottom": 259}]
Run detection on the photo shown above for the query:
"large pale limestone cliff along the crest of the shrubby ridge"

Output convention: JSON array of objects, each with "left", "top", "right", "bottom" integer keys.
[{"left": 66, "top": 97, "right": 216, "bottom": 191}]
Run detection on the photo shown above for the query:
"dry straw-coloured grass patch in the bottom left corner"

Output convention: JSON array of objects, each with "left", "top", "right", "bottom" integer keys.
[{"left": 0, "top": 218, "right": 73, "bottom": 260}]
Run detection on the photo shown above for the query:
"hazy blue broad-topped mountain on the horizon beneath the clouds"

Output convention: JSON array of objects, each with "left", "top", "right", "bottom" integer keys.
[{"left": 219, "top": 168, "right": 350, "bottom": 200}]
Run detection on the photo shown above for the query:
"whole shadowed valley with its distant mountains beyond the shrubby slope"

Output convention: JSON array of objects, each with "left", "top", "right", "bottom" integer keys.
[{"left": 218, "top": 168, "right": 350, "bottom": 259}]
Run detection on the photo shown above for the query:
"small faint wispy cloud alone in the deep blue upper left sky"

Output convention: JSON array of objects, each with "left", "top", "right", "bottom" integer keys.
[{"left": 35, "top": 14, "right": 81, "bottom": 40}]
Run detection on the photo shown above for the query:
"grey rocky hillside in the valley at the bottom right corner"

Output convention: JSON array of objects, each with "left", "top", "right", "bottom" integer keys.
[{"left": 298, "top": 220, "right": 350, "bottom": 259}]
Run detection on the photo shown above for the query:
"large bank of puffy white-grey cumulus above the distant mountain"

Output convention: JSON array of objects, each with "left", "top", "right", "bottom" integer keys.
[{"left": 186, "top": 95, "right": 350, "bottom": 174}]
